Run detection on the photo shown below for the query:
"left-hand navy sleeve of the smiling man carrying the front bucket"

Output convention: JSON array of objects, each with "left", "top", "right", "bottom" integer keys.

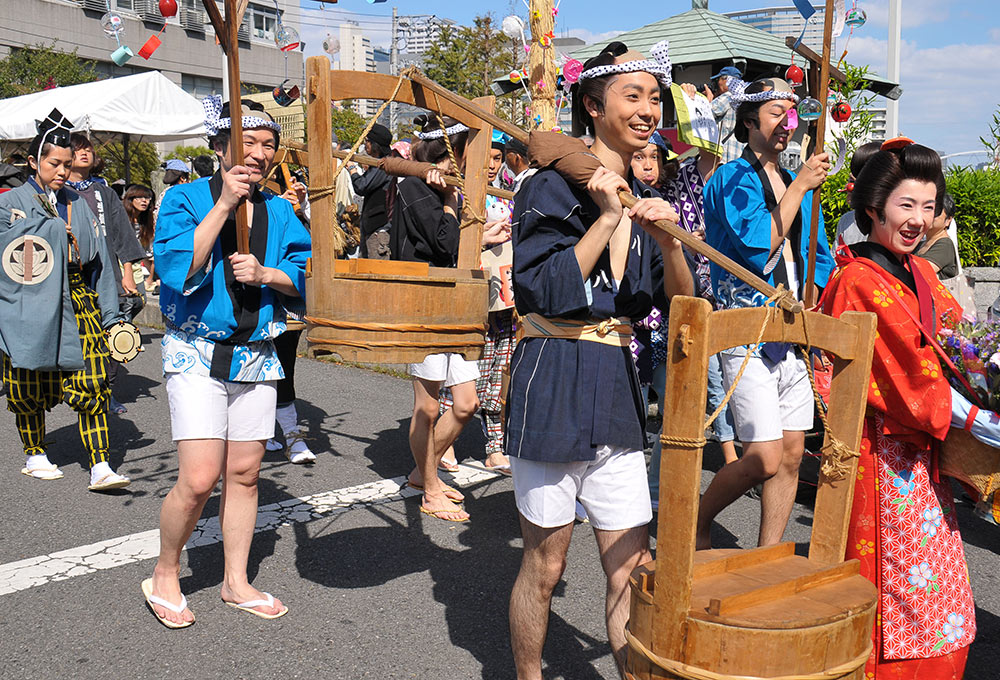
[{"left": 512, "top": 171, "right": 588, "bottom": 317}]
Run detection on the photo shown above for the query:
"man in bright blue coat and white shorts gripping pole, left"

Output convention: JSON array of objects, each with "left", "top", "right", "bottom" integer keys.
[{"left": 142, "top": 97, "right": 311, "bottom": 628}]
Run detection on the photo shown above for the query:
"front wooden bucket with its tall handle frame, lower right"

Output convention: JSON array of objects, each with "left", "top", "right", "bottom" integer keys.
[{"left": 628, "top": 297, "right": 876, "bottom": 680}]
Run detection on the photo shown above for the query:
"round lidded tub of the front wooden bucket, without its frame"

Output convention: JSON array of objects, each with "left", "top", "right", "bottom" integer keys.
[{"left": 627, "top": 543, "right": 877, "bottom": 680}]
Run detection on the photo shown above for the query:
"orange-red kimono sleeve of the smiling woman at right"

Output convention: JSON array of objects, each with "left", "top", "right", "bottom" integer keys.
[{"left": 824, "top": 263, "right": 951, "bottom": 439}]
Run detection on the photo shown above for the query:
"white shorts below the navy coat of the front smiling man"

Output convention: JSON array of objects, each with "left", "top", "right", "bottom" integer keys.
[{"left": 510, "top": 446, "right": 653, "bottom": 531}]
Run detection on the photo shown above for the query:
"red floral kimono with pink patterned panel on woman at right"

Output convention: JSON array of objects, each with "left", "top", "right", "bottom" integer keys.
[{"left": 823, "top": 243, "right": 976, "bottom": 680}]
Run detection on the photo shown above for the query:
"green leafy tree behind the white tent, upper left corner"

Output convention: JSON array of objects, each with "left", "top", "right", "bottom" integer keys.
[{"left": 0, "top": 40, "right": 98, "bottom": 99}]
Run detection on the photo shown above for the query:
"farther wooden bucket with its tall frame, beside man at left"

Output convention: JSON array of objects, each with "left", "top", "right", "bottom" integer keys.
[{"left": 306, "top": 57, "right": 494, "bottom": 364}]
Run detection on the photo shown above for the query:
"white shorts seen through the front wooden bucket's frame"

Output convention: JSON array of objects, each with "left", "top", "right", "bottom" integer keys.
[{"left": 719, "top": 348, "right": 815, "bottom": 442}]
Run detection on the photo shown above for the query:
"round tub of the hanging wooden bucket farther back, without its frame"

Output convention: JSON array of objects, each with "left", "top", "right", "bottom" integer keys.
[{"left": 306, "top": 259, "right": 489, "bottom": 364}]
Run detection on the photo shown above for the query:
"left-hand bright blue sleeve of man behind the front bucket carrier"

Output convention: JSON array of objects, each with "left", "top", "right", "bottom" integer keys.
[{"left": 704, "top": 162, "right": 778, "bottom": 278}]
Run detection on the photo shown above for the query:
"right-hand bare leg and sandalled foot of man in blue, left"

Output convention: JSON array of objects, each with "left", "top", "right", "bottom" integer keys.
[{"left": 219, "top": 439, "right": 284, "bottom": 614}]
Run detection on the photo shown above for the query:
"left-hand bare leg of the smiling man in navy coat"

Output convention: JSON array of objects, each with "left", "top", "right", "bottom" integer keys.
[{"left": 510, "top": 516, "right": 573, "bottom": 680}]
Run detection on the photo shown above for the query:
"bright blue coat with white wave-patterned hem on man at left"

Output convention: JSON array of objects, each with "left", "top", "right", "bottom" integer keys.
[{"left": 153, "top": 173, "right": 311, "bottom": 382}]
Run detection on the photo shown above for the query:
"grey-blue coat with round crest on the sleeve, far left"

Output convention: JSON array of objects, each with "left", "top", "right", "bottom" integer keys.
[{"left": 0, "top": 180, "right": 121, "bottom": 371}]
